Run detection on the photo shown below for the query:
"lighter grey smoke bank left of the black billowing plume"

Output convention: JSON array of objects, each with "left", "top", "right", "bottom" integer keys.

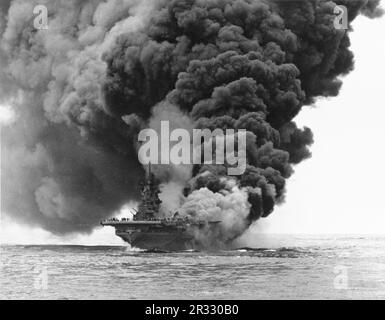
[{"left": 0, "top": 0, "right": 159, "bottom": 233}]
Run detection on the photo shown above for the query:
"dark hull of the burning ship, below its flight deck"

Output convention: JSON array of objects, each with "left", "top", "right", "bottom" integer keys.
[{"left": 117, "top": 232, "right": 197, "bottom": 251}]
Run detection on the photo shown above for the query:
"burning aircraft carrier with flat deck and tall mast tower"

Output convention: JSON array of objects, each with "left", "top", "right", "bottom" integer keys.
[{"left": 101, "top": 165, "right": 220, "bottom": 251}]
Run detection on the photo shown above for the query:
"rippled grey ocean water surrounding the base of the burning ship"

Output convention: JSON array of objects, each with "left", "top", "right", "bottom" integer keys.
[{"left": 0, "top": 235, "right": 385, "bottom": 299}]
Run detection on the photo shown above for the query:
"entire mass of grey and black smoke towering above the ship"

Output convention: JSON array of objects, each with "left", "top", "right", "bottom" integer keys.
[{"left": 0, "top": 0, "right": 382, "bottom": 238}]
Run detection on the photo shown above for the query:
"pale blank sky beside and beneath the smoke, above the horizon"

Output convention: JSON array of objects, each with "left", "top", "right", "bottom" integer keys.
[{"left": 0, "top": 13, "right": 385, "bottom": 244}]
